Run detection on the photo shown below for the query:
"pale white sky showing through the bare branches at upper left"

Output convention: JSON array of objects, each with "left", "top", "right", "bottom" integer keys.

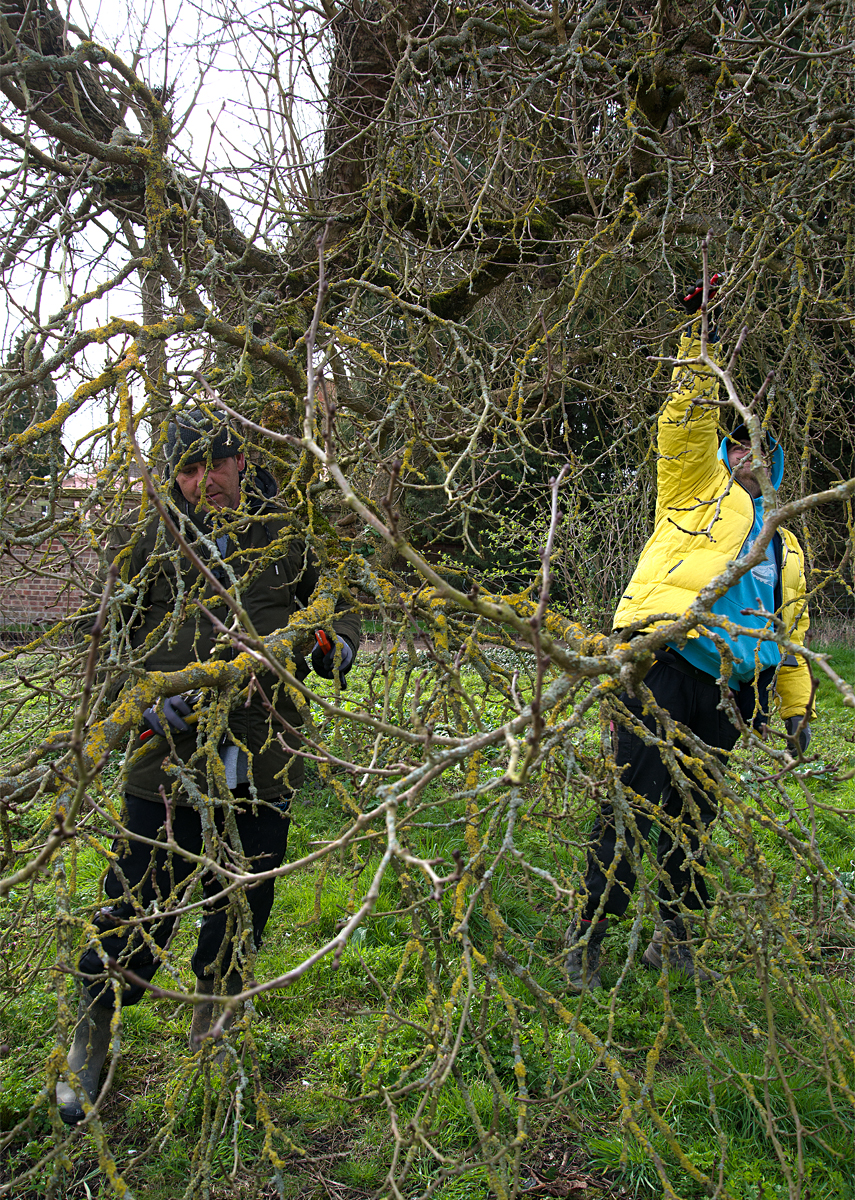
[{"left": 8, "top": 0, "right": 325, "bottom": 446}]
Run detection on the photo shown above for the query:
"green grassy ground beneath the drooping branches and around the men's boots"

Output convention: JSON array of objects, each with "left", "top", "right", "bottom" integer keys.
[{"left": 0, "top": 647, "right": 855, "bottom": 1200}]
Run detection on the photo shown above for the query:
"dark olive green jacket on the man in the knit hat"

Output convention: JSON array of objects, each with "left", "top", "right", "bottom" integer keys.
[{"left": 114, "top": 468, "right": 360, "bottom": 804}]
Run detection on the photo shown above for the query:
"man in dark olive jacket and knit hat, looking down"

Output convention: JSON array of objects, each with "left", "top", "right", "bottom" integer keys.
[{"left": 56, "top": 410, "right": 359, "bottom": 1124}]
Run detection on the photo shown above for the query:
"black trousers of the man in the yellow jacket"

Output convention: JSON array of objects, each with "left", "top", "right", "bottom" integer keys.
[{"left": 582, "top": 659, "right": 773, "bottom": 920}]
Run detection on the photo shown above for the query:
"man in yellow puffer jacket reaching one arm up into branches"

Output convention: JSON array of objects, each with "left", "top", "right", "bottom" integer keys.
[{"left": 564, "top": 285, "right": 812, "bottom": 991}]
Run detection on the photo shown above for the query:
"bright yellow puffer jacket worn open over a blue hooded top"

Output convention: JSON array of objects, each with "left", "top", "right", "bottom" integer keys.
[{"left": 614, "top": 335, "right": 811, "bottom": 718}]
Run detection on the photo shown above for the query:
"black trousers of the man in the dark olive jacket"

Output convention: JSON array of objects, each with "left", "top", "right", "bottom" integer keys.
[{"left": 79, "top": 784, "right": 289, "bottom": 1008}]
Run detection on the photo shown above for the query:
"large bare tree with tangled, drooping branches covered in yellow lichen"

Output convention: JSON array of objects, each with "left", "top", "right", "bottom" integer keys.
[{"left": 0, "top": 0, "right": 855, "bottom": 1198}]
